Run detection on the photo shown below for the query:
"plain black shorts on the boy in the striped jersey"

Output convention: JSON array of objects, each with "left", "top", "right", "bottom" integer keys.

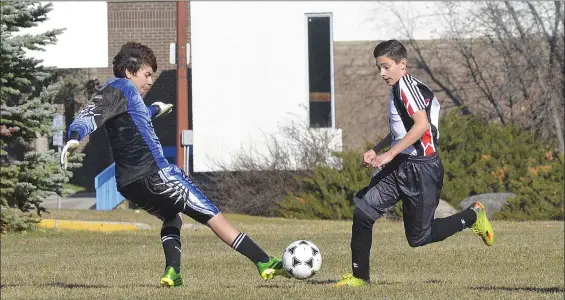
[{"left": 354, "top": 153, "right": 444, "bottom": 243}]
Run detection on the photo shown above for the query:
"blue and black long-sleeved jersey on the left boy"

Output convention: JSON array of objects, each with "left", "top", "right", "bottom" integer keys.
[{"left": 67, "top": 78, "right": 169, "bottom": 190}]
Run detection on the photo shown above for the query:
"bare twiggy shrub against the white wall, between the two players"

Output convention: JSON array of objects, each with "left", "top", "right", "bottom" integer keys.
[{"left": 197, "top": 115, "right": 337, "bottom": 216}]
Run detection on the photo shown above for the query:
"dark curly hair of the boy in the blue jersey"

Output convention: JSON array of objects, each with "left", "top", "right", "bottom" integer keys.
[{"left": 112, "top": 42, "right": 157, "bottom": 78}]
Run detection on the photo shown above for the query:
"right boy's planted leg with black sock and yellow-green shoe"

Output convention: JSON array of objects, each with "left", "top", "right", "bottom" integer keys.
[{"left": 336, "top": 160, "right": 399, "bottom": 286}]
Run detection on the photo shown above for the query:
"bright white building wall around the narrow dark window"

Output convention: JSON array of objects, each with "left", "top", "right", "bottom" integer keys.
[{"left": 191, "top": 1, "right": 446, "bottom": 172}]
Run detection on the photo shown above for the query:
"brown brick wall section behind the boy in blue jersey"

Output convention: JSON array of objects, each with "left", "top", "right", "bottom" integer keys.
[{"left": 74, "top": 0, "right": 191, "bottom": 190}]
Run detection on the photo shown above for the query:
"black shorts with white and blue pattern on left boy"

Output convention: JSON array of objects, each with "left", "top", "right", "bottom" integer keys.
[{"left": 120, "top": 165, "right": 220, "bottom": 224}]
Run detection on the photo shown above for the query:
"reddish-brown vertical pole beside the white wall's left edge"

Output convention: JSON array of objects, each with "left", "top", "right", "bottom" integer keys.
[{"left": 176, "top": 1, "right": 189, "bottom": 169}]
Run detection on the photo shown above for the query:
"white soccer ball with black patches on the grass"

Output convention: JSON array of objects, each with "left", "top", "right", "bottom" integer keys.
[{"left": 282, "top": 240, "right": 322, "bottom": 279}]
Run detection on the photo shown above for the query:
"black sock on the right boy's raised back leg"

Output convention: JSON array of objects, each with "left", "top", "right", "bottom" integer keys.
[{"left": 429, "top": 209, "right": 477, "bottom": 243}]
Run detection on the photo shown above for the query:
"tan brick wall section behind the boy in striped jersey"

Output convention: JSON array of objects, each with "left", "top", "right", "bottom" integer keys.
[{"left": 334, "top": 41, "right": 496, "bottom": 150}]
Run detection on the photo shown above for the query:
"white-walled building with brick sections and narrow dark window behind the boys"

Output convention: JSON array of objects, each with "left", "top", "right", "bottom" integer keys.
[{"left": 23, "top": 1, "right": 450, "bottom": 176}]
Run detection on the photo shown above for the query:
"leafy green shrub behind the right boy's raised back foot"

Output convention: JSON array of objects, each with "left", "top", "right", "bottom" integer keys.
[{"left": 439, "top": 110, "right": 564, "bottom": 219}]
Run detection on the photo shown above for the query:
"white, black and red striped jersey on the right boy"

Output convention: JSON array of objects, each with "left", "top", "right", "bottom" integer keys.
[{"left": 388, "top": 73, "right": 440, "bottom": 156}]
